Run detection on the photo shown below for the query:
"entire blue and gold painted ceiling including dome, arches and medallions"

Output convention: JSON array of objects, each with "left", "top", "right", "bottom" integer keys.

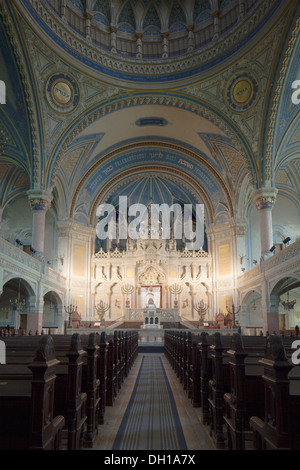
[{"left": 0, "top": 0, "right": 299, "bottom": 239}]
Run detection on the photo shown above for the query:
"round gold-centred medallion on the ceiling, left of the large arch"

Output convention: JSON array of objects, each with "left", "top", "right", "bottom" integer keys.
[{"left": 46, "top": 73, "right": 79, "bottom": 113}]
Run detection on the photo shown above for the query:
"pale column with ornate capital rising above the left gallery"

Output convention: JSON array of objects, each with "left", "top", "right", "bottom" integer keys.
[{"left": 27, "top": 189, "right": 52, "bottom": 253}]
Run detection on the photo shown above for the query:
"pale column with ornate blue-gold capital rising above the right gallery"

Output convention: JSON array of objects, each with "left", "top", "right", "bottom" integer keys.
[{"left": 252, "top": 188, "right": 278, "bottom": 259}]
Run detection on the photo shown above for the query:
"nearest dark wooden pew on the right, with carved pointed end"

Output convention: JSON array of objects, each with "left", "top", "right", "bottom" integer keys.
[{"left": 250, "top": 335, "right": 300, "bottom": 450}]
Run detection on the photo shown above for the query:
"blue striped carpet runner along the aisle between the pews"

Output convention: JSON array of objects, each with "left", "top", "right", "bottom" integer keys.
[{"left": 112, "top": 355, "right": 187, "bottom": 450}]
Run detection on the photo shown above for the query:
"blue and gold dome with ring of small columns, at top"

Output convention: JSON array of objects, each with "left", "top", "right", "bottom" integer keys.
[{"left": 7, "top": 0, "right": 288, "bottom": 83}]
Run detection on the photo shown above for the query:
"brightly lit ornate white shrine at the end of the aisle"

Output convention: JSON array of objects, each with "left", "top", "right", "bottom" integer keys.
[{"left": 92, "top": 239, "right": 212, "bottom": 322}]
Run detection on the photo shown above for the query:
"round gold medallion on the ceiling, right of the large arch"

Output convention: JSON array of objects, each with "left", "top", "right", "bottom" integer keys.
[{"left": 225, "top": 71, "right": 259, "bottom": 112}]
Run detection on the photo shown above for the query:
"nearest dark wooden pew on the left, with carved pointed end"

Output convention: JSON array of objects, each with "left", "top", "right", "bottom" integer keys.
[{"left": 0, "top": 336, "right": 65, "bottom": 450}]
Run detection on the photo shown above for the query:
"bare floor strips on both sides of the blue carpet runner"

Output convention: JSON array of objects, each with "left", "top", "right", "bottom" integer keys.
[{"left": 92, "top": 354, "right": 214, "bottom": 450}]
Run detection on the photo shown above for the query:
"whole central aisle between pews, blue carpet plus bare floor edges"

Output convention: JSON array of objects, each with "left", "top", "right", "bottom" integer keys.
[{"left": 93, "top": 354, "right": 214, "bottom": 450}]
